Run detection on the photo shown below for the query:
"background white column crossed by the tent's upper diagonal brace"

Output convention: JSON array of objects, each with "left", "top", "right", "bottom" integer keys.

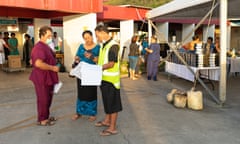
[{"left": 182, "top": 24, "right": 195, "bottom": 44}]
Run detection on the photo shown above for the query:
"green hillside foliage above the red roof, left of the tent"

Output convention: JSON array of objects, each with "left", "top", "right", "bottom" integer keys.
[{"left": 104, "top": 0, "right": 172, "bottom": 8}]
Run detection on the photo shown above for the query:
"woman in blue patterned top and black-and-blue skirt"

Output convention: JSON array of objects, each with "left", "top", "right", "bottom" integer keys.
[{"left": 72, "top": 30, "right": 100, "bottom": 122}]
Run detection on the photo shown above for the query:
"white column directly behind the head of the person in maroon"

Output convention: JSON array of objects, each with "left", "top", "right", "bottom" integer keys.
[{"left": 33, "top": 18, "right": 51, "bottom": 43}]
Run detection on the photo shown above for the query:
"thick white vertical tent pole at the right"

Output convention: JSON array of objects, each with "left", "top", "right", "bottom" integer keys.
[{"left": 219, "top": 0, "right": 228, "bottom": 103}]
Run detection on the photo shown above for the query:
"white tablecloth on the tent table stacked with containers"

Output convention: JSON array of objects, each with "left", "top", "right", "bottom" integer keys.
[{"left": 165, "top": 61, "right": 220, "bottom": 82}]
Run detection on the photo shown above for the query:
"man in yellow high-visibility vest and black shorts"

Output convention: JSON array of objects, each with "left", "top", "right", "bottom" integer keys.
[{"left": 95, "top": 25, "right": 122, "bottom": 136}]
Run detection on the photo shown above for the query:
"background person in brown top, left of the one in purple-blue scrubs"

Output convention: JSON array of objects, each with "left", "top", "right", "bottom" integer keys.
[{"left": 128, "top": 36, "right": 139, "bottom": 80}]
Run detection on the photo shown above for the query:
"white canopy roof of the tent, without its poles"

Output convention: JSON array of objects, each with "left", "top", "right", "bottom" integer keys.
[{"left": 148, "top": 0, "right": 240, "bottom": 21}]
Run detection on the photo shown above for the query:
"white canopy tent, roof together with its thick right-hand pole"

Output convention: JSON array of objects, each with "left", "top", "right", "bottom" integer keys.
[{"left": 147, "top": 0, "right": 240, "bottom": 104}]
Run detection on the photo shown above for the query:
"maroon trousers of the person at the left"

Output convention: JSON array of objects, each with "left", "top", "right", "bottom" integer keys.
[{"left": 34, "top": 84, "right": 53, "bottom": 122}]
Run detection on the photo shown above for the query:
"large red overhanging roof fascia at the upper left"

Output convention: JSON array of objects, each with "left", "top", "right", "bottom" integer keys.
[{"left": 0, "top": 0, "right": 103, "bottom": 18}]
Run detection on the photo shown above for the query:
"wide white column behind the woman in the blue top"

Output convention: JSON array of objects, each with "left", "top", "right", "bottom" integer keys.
[{"left": 63, "top": 13, "right": 97, "bottom": 71}]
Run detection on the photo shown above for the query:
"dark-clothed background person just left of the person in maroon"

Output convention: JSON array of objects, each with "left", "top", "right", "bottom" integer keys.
[{"left": 23, "top": 34, "right": 33, "bottom": 67}]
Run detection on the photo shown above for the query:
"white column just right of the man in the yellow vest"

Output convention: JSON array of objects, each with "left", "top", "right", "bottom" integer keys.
[{"left": 120, "top": 20, "right": 134, "bottom": 59}]
